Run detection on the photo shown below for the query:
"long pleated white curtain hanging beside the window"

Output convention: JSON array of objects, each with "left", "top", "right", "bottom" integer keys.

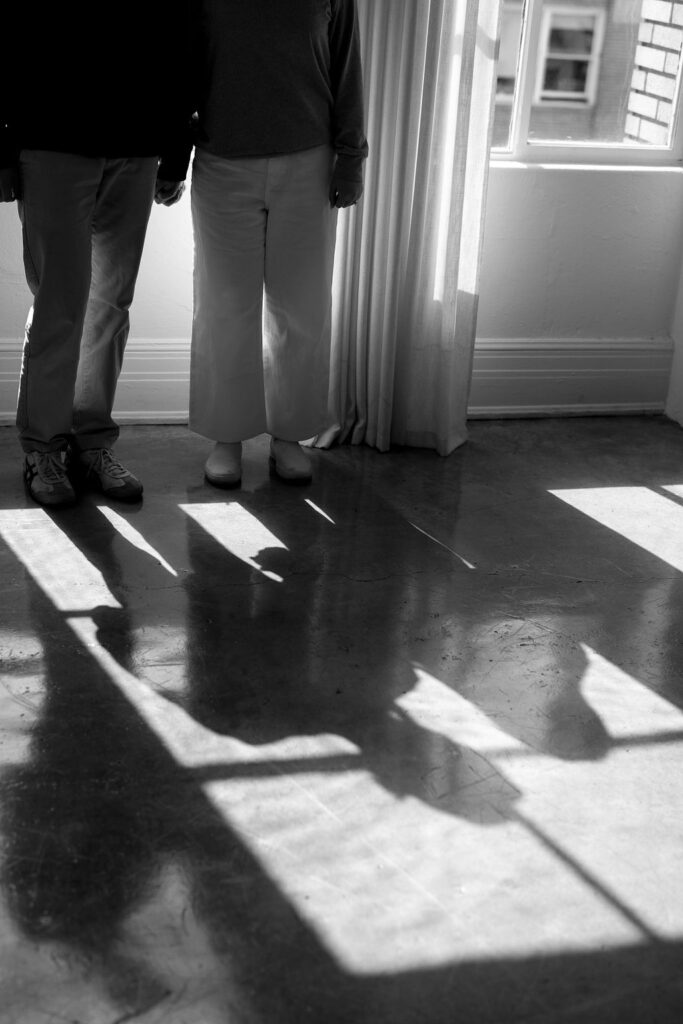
[{"left": 316, "top": 0, "right": 500, "bottom": 455}]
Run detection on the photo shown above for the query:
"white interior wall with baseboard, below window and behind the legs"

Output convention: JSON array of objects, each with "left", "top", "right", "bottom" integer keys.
[{"left": 0, "top": 164, "right": 683, "bottom": 423}]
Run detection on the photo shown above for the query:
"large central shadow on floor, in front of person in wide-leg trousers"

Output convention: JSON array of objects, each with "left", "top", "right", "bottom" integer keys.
[{"left": 182, "top": 483, "right": 520, "bottom": 824}]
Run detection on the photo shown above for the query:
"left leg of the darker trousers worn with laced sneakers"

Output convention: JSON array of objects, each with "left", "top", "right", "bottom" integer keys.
[{"left": 16, "top": 150, "right": 103, "bottom": 452}]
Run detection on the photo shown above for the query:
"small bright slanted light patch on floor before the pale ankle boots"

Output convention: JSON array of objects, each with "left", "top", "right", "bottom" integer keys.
[{"left": 179, "top": 502, "right": 288, "bottom": 583}]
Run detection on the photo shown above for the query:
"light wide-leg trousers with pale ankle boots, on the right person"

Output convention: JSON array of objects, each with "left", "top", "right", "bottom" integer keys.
[{"left": 189, "top": 146, "right": 337, "bottom": 483}]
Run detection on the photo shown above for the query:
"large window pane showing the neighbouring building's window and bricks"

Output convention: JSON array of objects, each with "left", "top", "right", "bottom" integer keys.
[{"left": 529, "top": 0, "right": 683, "bottom": 146}]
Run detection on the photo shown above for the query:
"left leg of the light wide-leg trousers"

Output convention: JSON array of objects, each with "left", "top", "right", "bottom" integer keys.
[{"left": 189, "top": 150, "right": 268, "bottom": 441}]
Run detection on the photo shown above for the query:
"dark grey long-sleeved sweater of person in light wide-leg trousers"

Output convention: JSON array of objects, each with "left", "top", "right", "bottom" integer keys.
[{"left": 174, "top": 0, "right": 368, "bottom": 181}]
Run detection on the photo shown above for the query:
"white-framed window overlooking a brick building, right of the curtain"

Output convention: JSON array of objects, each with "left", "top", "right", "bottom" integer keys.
[{"left": 493, "top": 0, "right": 683, "bottom": 163}]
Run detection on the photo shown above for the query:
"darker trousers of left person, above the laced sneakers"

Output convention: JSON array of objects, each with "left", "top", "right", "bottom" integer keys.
[{"left": 16, "top": 150, "right": 158, "bottom": 504}]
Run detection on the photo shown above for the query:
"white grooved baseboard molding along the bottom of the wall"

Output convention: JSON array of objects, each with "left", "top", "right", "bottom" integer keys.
[{"left": 0, "top": 338, "right": 674, "bottom": 424}]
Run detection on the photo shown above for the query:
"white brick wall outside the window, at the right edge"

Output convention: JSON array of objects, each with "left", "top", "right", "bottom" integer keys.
[{"left": 626, "top": 0, "right": 683, "bottom": 145}]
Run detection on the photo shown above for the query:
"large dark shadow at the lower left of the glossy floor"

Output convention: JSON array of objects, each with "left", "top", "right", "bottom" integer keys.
[{"left": 2, "top": 587, "right": 179, "bottom": 952}]
